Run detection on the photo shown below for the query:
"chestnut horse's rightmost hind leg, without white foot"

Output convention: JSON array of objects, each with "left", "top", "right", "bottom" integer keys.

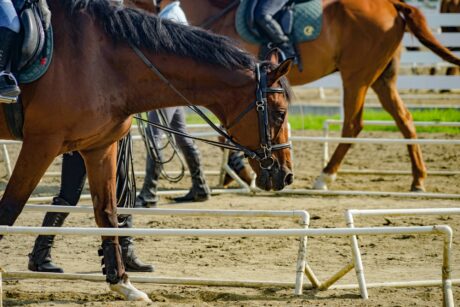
[{"left": 372, "top": 56, "right": 426, "bottom": 192}]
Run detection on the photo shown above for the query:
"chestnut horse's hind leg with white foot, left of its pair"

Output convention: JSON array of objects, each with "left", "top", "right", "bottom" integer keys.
[{"left": 313, "top": 83, "right": 368, "bottom": 190}]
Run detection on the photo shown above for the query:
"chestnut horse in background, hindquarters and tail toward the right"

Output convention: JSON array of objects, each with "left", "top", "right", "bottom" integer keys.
[{"left": 142, "top": 0, "right": 460, "bottom": 191}]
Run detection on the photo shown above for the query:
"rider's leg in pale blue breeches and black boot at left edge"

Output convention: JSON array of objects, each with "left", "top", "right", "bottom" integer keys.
[{"left": 0, "top": 0, "right": 21, "bottom": 103}]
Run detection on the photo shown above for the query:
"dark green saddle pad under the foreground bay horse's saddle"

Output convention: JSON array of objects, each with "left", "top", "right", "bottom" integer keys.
[{"left": 17, "top": 26, "right": 53, "bottom": 84}]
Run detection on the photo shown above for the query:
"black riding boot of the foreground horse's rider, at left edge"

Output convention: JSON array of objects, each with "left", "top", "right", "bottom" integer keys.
[{"left": 0, "top": 27, "right": 21, "bottom": 103}]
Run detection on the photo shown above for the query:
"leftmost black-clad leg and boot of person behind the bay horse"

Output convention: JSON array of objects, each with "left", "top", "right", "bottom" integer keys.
[{"left": 28, "top": 152, "right": 86, "bottom": 273}]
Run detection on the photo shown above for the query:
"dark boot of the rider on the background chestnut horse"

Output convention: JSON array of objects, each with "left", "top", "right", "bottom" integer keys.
[{"left": 256, "top": 15, "right": 297, "bottom": 60}]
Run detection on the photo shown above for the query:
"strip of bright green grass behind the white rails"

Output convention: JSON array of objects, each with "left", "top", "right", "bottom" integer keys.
[{"left": 187, "top": 109, "right": 460, "bottom": 133}]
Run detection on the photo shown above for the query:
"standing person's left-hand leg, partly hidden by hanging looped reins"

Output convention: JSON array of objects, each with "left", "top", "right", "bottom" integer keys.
[{"left": 135, "top": 111, "right": 161, "bottom": 208}]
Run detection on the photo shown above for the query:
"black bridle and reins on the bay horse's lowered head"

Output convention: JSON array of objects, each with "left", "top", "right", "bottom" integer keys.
[{"left": 131, "top": 44, "right": 291, "bottom": 170}]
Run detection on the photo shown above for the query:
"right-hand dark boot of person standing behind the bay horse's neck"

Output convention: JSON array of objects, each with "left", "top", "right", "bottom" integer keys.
[{"left": 174, "top": 144, "right": 211, "bottom": 203}]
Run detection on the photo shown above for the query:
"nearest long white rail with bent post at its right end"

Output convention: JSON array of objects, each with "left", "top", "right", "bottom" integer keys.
[{"left": 0, "top": 225, "right": 454, "bottom": 307}]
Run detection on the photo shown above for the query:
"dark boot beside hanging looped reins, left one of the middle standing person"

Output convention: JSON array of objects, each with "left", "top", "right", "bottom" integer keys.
[{"left": 134, "top": 155, "right": 161, "bottom": 208}]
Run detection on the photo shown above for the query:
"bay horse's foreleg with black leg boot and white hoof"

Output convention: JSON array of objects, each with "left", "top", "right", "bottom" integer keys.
[{"left": 81, "top": 143, "right": 150, "bottom": 301}]
